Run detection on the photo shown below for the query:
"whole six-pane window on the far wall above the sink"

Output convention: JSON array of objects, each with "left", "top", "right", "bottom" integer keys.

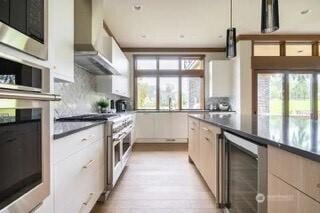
[{"left": 134, "top": 55, "right": 204, "bottom": 110}]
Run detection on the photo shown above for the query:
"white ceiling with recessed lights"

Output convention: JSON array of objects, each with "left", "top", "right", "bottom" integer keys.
[{"left": 104, "top": 0, "right": 320, "bottom": 47}]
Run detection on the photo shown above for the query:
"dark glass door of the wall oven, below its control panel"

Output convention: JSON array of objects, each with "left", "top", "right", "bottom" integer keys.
[{"left": 0, "top": 98, "right": 50, "bottom": 213}]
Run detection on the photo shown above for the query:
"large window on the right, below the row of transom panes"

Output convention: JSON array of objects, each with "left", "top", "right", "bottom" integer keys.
[{"left": 256, "top": 71, "right": 320, "bottom": 118}]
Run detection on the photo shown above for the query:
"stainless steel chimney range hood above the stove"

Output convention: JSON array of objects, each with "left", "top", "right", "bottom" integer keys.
[{"left": 74, "top": 0, "right": 119, "bottom": 75}]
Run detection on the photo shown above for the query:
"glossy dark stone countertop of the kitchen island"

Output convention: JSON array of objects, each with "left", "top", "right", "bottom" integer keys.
[{"left": 189, "top": 113, "right": 320, "bottom": 162}]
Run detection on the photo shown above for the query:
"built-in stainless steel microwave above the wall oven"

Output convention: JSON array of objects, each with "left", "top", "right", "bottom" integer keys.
[{"left": 0, "top": 0, "right": 48, "bottom": 60}]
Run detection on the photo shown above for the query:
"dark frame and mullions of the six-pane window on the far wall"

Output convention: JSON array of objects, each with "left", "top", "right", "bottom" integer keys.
[{"left": 133, "top": 54, "right": 205, "bottom": 111}]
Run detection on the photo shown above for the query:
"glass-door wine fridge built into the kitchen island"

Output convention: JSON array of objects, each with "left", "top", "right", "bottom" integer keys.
[{"left": 218, "top": 132, "right": 267, "bottom": 213}]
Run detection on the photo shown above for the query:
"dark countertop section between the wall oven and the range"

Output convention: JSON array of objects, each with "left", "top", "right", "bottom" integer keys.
[{"left": 53, "top": 121, "right": 105, "bottom": 140}]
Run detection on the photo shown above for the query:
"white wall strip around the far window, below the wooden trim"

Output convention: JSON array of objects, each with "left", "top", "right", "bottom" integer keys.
[{"left": 125, "top": 52, "right": 226, "bottom": 105}]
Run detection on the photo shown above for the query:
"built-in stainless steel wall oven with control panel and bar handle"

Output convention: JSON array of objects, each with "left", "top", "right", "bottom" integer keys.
[{"left": 0, "top": 54, "right": 59, "bottom": 213}]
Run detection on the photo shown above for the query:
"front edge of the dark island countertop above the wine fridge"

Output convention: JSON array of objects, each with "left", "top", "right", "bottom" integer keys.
[{"left": 188, "top": 114, "right": 320, "bottom": 163}]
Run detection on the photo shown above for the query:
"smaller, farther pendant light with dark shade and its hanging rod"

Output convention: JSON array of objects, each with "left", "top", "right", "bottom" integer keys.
[{"left": 227, "top": 0, "right": 237, "bottom": 58}]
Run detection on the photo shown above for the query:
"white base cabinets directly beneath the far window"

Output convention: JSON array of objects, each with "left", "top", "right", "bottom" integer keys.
[{"left": 136, "top": 112, "right": 188, "bottom": 142}]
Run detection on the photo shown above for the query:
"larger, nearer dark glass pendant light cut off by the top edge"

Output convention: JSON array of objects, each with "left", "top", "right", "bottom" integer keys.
[{"left": 261, "top": 0, "right": 279, "bottom": 33}]
